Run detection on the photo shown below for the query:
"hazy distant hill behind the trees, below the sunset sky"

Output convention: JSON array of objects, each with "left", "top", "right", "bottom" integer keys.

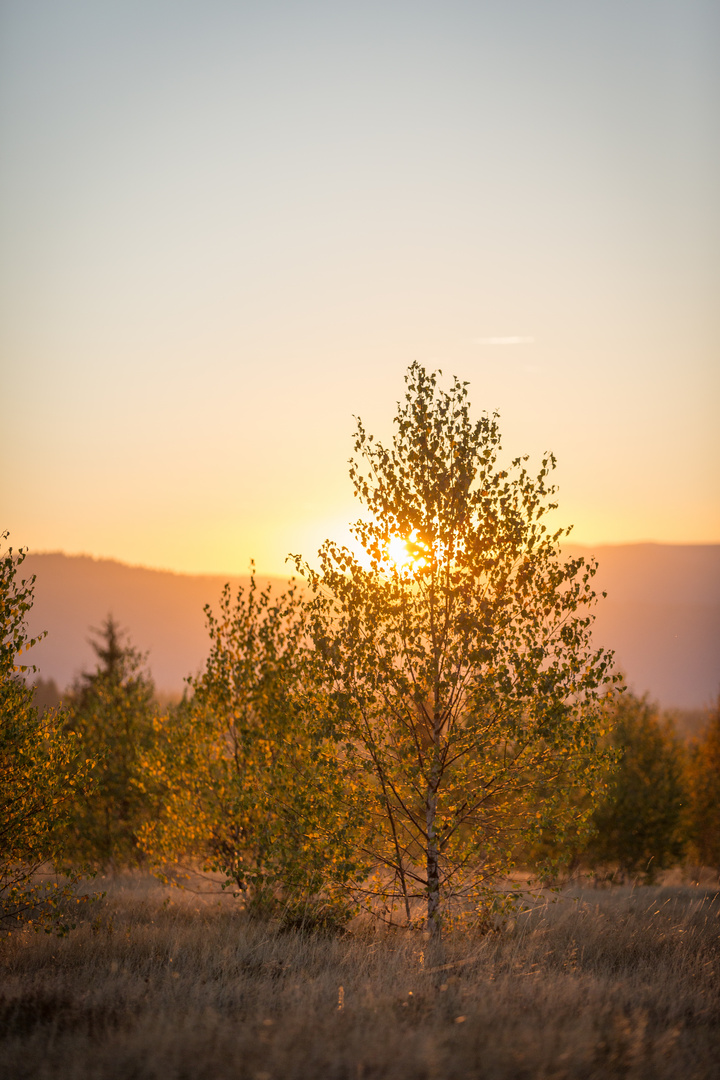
[{"left": 23, "top": 544, "right": 720, "bottom": 710}]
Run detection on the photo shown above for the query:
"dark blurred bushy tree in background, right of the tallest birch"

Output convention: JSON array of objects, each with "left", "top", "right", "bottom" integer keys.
[{"left": 588, "top": 692, "right": 688, "bottom": 880}]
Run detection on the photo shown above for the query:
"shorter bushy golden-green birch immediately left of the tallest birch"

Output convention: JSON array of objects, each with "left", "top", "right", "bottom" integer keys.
[{"left": 141, "top": 578, "right": 367, "bottom": 922}]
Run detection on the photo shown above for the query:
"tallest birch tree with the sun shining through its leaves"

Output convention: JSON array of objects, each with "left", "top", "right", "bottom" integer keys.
[{"left": 297, "top": 364, "right": 617, "bottom": 929}]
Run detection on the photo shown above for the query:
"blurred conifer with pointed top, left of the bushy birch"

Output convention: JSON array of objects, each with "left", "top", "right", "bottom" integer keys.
[{"left": 63, "top": 616, "right": 155, "bottom": 867}]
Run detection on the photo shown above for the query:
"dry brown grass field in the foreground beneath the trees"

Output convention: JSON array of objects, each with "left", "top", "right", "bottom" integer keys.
[{"left": 0, "top": 877, "right": 720, "bottom": 1080}]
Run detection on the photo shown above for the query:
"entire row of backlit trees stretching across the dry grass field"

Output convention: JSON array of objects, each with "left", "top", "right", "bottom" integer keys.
[{"left": 0, "top": 364, "right": 720, "bottom": 940}]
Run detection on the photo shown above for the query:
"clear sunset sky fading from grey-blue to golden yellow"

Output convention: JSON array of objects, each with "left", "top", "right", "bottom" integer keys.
[{"left": 0, "top": 0, "right": 720, "bottom": 572}]
